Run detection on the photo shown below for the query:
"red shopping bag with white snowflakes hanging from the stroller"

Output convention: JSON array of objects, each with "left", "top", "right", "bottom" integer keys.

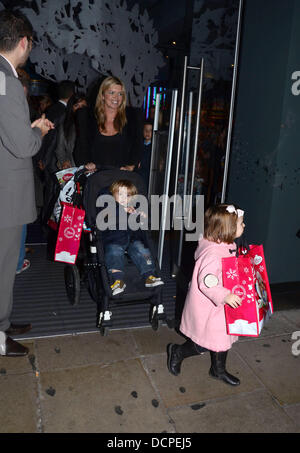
[{"left": 54, "top": 203, "right": 85, "bottom": 264}]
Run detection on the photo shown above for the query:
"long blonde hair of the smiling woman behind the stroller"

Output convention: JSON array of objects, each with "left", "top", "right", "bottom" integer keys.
[{"left": 95, "top": 76, "right": 127, "bottom": 132}]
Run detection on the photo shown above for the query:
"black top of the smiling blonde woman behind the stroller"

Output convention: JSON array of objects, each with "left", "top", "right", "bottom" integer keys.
[{"left": 90, "top": 107, "right": 144, "bottom": 168}]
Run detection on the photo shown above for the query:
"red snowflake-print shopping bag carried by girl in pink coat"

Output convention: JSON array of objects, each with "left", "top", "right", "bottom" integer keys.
[{"left": 222, "top": 245, "right": 273, "bottom": 337}]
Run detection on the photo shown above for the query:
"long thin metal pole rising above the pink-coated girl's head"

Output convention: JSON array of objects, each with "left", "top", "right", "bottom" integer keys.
[{"left": 221, "top": 0, "right": 243, "bottom": 203}]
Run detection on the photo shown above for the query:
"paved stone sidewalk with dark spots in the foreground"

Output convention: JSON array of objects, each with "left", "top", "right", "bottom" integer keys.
[{"left": 0, "top": 309, "right": 300, "bottom": 433}]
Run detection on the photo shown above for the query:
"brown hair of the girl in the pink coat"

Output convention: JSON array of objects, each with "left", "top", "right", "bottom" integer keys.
[{"left": 204, "top": 204, "right": 238, "bottom": 244}]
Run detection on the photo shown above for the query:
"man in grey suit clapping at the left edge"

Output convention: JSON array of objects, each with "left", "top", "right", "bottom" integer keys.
[{"left": 0, "top": 10, "right": 53, "bottom": 357}]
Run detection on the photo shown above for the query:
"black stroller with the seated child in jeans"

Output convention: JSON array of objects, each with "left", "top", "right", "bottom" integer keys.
[{"left": 64, "top": 168, "right": 166, "bottom": 336}]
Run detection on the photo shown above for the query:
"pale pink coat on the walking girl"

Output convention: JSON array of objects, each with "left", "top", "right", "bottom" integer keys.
[{"left": 180, "top": 239, "right": 238, "bottom": 352}]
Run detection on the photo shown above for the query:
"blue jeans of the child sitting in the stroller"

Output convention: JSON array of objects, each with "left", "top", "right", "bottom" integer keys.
[{"left": 105, "top": 241, "right": 155, "bottom": 280}]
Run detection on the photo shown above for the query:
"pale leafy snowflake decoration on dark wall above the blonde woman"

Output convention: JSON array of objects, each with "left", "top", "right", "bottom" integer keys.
[{"left": 22, "top": 0, "right": 165, "bottom": 106}]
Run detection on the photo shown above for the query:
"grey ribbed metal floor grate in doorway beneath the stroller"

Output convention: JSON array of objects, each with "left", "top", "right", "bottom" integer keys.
[{"left": 11, "top": 245, "right": 176, "bottom": 338}]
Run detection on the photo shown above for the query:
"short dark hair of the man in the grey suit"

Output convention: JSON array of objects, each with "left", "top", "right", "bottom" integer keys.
[{"left": 0, "top": 9, "right": 33, "bottom": 52}]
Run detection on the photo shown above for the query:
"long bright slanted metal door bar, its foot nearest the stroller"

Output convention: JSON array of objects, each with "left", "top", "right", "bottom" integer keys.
[{"left": 157, "top": 90, "right": 178, "bottom": 269}]
